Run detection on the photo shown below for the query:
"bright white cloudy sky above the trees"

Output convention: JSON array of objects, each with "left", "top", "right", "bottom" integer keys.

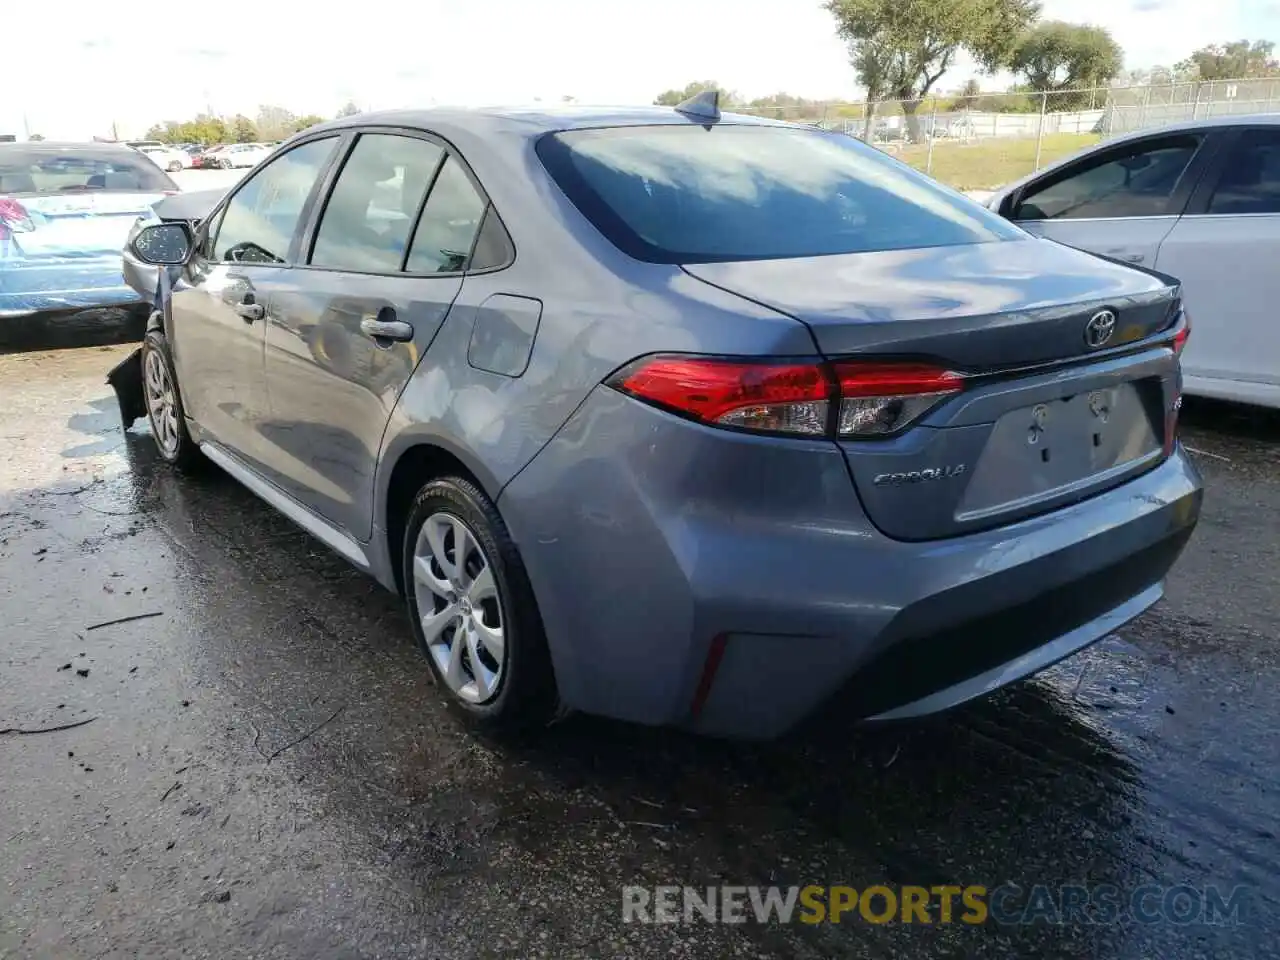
[{"left": 0, "top": 0, "right": 1280, "bottom": 138}]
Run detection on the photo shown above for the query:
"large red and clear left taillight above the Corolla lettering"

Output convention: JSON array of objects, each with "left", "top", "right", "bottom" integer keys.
[{"left": 609, "top": 356, "right": 963, "bottom": 438}]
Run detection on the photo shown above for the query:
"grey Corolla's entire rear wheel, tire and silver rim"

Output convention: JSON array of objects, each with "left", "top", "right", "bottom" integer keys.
[{"left": 403, "top": 476, "right": 557, "bottom": 730}]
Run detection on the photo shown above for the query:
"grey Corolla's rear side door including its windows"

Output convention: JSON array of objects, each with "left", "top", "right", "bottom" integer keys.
[{"left": 265, "top": 128, "right": 488, "bottom": 540}]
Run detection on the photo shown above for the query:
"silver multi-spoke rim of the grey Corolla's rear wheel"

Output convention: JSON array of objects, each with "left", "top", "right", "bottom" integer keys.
[{"left": 413, "top": 513, "right": 507, "bottom": 704}]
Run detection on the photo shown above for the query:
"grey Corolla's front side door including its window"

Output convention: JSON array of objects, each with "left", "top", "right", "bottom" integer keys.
[{"left": 170, "top": 137, "right": 338, "bottom": 466}]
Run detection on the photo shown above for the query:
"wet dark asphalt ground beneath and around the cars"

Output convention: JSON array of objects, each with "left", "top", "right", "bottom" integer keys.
[{"left": 0, "top": 347, "right": 1280, "bottom": 960}]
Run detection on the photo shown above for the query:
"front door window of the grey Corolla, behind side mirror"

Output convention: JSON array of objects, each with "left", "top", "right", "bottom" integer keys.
[{"left": 214, "top": 137, "right": 338, "bottom": 264}]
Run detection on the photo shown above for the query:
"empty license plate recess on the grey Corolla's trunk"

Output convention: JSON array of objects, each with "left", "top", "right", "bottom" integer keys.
[{"left": 956, "top": 383, "right": 1161, "bottom": 522}]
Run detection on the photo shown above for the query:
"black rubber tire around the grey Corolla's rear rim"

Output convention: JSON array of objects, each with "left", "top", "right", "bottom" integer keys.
[{"left": 401, "top": 476, "right": 558, "bottom": 732}]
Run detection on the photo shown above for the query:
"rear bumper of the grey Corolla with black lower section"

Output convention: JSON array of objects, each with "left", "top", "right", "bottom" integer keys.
[{"left": 499, "top": 388, "right": 1202, "bottom": 737}]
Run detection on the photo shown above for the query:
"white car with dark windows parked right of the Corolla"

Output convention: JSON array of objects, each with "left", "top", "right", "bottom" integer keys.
[{"left": 987, "top": 115, "right": 1280, "bottom": 408}]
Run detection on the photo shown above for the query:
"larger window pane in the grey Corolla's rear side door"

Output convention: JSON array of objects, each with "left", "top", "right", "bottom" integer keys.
[{"left": 310, "top": 133, "right": 444, "bottom": 273}]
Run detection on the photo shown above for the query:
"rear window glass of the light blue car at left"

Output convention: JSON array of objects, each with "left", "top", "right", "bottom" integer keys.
[{"left": 0, "top": 146, "right": 178, "bottom": 195}]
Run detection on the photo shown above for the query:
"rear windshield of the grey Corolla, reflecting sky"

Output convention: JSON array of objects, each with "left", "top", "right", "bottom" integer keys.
[{"left": 536, "top": 124, "right": 1027, "bottom": 264}]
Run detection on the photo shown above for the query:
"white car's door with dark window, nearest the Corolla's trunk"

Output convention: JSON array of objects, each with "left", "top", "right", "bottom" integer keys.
[{"left": 1000, "top": 131, "right": 1216, "bottom": 266}]
